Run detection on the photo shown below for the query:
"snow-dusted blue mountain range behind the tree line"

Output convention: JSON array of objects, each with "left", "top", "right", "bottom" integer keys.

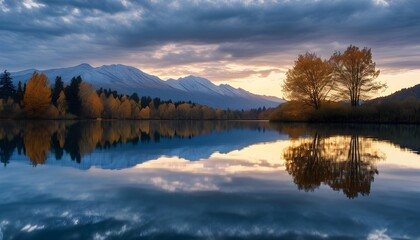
[{"left": 11, "top": 63, "right": 284, "bottom": 109}]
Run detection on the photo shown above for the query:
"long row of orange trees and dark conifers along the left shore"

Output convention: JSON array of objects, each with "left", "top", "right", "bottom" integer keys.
[{"left": 0, "top": 71, "right": 270, "bottom": 120}]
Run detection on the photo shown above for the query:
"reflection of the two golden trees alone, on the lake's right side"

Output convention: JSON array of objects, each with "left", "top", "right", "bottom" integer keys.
[{"left": 283, "top": 133, "right": 385, "bottom": 198}]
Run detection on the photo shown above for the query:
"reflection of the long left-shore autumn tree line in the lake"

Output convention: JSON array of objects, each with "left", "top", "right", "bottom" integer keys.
[{"left": 0, "top": 121, "right": 269, "bottom": 166}]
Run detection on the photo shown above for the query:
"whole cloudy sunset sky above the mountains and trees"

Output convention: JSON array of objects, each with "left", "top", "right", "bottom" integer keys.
[{"left": 0, "top": 0, "right": 420, "bottom": 97}]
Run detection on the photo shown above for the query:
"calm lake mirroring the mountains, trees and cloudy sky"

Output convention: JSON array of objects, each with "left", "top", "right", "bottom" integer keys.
[{"left": 0, "top": 121, "right": 420, "bottom": 240}]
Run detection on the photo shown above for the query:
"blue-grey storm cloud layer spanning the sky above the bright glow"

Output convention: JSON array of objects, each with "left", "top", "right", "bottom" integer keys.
[{"left": 0, "top": 0, "right": 420, "bottom": 71}]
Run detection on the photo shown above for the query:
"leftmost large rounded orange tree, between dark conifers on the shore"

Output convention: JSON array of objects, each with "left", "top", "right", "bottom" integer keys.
[{"left": 23, "top": 73, "right": 51, "bottom": 118}]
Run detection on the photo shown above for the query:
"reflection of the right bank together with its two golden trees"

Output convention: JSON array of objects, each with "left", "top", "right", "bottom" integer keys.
[{"left": 271, "top": 124, "right": 420, "bottom": 198}]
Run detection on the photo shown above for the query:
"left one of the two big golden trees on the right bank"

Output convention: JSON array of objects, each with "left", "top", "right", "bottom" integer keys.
[{"left": 282, "top": 53, "right": 333, "bottom": 109}]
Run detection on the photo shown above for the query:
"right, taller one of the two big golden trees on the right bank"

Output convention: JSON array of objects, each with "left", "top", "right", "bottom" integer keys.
[{"left": 330, "top": 45, "right": 386, "bottom": 106}]
